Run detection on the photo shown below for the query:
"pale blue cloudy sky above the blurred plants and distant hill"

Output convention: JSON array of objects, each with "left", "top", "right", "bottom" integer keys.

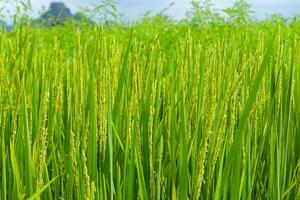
[{"left": 0, "top": 0, "right": 300, "bottom": 21}]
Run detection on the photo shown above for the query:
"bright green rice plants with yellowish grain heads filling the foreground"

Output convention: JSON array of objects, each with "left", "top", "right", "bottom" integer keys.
[{"left": 0, "top": 24, "right": 300, "bottom": 200}]
